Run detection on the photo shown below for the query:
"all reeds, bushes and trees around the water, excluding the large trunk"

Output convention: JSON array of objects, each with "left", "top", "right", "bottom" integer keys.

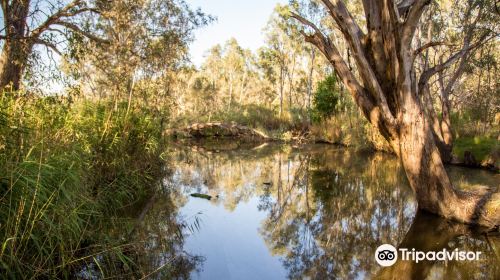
[{"left": 0, "top": 0, "right": 500, "bottom": 278}]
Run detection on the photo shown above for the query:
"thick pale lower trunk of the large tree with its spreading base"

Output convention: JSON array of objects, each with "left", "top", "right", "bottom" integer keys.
[{"left": 391, "top": 93, "right": 500, "bottom": 227}]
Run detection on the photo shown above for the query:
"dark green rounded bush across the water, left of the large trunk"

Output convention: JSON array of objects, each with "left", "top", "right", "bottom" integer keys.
[{"left": 311, "top": 75, "right": 340, "bottom": 123}]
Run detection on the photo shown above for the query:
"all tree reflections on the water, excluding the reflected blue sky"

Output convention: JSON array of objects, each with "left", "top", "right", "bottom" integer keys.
[{"left": 170, "top": 145, "right": 499, "bottom": 279}]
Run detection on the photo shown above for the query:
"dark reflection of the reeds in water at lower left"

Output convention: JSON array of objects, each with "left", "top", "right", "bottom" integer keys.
[{"left": 76, "top": 182, "right": 204, "bottom": 280}]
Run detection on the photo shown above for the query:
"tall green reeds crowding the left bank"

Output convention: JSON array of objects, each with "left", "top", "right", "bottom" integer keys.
[{"left": 0, "top": 92, "right": 168, "bottom": 279}]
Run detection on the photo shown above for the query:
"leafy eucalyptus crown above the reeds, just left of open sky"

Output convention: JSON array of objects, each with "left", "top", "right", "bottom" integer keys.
[{"left": 65, "top": 0, "right": 212, "bottom": 106}]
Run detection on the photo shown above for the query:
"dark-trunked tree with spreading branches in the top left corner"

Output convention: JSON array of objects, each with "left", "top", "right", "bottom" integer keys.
[{"left": 0, "top": 0, "right": 106, "bottom": 90}]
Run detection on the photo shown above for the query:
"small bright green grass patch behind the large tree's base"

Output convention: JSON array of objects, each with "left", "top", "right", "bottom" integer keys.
[{"left": 453, "top": 136, "right": 500, "bottom": 161}]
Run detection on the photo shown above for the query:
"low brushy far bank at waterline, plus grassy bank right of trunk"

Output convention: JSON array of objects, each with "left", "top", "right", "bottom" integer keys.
[{"left": 164, "top": 121, "right": 500, "bottom": 172}]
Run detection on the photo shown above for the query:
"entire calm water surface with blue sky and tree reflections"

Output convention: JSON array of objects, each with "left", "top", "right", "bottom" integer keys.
[{"left": 150, "top": 145, "right": 500, "bottom": 279}]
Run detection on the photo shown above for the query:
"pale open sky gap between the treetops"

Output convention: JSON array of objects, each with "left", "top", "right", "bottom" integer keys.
[{"left": 186, "top": 0, "right": 288, "bottom": 67}]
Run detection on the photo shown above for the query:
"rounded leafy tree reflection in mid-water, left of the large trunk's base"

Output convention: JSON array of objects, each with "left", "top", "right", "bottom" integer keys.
[{"left": 261, "top": 149, "right": 415, "bottom": 279}]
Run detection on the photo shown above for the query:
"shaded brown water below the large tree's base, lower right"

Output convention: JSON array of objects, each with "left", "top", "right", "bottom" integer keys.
[{"left": 374, "top": 212, "right": 500, "bottom": 279}]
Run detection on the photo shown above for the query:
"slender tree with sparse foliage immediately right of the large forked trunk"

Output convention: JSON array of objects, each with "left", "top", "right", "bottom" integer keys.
[{"left": 416, "top": 0, "right": 500, "bottom": 162}]
